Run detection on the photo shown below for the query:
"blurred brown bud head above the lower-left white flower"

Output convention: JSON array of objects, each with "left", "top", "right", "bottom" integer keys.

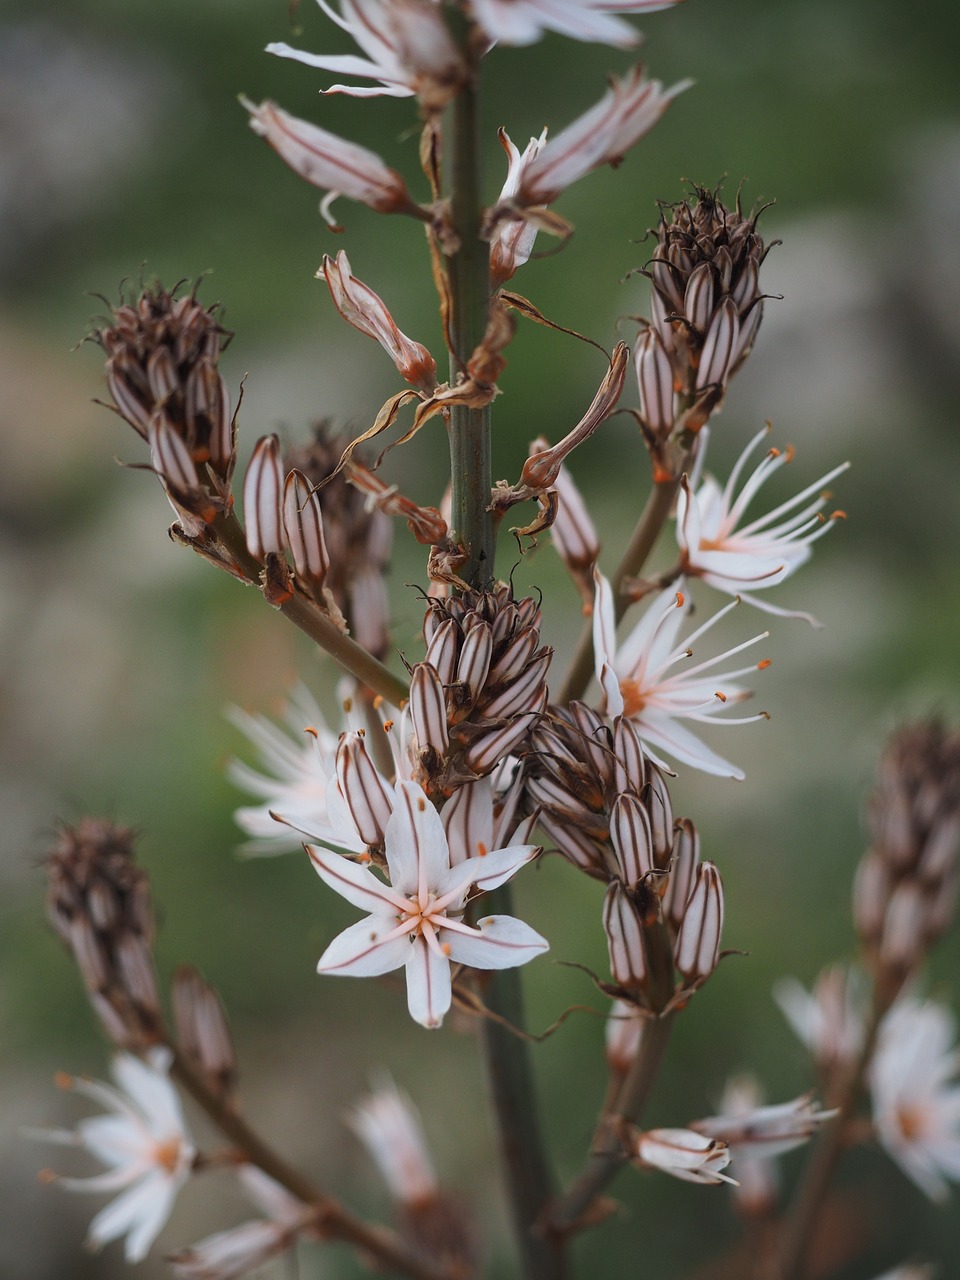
[{"left": 46, "top": 818, "right": 163, "bottom": 1048}]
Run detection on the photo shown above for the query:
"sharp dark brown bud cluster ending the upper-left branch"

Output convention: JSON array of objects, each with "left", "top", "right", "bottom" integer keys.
[{"left": 92, "top": 284, "right": 237, "bottom": 538}]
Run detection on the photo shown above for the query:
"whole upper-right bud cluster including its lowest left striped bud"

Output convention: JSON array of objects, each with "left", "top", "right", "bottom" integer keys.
[{"left": 635, "top": 180, "right": 767, "bottom": 460}]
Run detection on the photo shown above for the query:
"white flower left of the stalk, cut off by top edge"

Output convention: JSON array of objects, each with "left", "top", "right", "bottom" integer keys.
[{"left": 266, "top": 0, "right": 466, "bottom": 106}]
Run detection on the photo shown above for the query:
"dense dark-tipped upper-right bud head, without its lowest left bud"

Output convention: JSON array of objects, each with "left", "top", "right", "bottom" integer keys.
[{"left": 644, "top": 187, "right": 767, "bottom": 406}]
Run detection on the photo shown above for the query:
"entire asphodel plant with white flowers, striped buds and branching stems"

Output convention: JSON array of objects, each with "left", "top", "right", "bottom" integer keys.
[{"left": 28, "top": 0, "right": 960, "bottom": 1280}]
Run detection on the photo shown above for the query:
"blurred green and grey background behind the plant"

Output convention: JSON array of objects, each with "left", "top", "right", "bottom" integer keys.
[{"left": 0, "top": 0, "right": 960, "bottom": 1280}]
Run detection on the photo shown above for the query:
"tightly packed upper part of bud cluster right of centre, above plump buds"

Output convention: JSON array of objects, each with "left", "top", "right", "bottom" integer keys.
[{"left": 525, "top": 701, "right": 673, "bottom": 887}]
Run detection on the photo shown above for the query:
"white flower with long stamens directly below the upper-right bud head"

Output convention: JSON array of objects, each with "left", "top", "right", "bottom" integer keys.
[{"left": 677, "top": 428, "right": 850, "bottom": 622}]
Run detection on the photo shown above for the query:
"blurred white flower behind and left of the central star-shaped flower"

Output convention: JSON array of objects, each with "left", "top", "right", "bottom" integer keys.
[{"left": 227, "top": 685, "right": 337, "bottom": 854}]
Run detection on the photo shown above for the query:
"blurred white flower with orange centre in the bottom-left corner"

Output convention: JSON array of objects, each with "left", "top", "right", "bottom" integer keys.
[{"left": 32, "top": 1050, "right": 196, "bottom": 1262}]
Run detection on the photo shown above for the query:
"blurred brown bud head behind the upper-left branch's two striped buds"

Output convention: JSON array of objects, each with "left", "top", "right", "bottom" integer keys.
[{"left": 283, "top": 422, "right": 393, "bottom": 658}]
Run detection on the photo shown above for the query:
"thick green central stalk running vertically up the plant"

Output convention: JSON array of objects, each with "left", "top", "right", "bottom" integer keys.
[{"left": 447, "top": 49, "right": 563, "bottom": 1280}]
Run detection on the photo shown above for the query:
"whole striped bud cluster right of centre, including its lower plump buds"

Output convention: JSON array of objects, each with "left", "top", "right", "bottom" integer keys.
[{"left": 525, "top": 701, "right": 723, "bottom": 1018}]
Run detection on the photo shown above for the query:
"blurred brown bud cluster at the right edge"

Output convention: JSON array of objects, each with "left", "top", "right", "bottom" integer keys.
[{"left": 854, "top": 721, "right": 960, "bottom": 997}]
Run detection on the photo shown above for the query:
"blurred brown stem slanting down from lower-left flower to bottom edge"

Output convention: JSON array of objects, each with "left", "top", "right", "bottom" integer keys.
[{"left": 170, "top": 1053, "right": 451, "bottom": 1280}]
